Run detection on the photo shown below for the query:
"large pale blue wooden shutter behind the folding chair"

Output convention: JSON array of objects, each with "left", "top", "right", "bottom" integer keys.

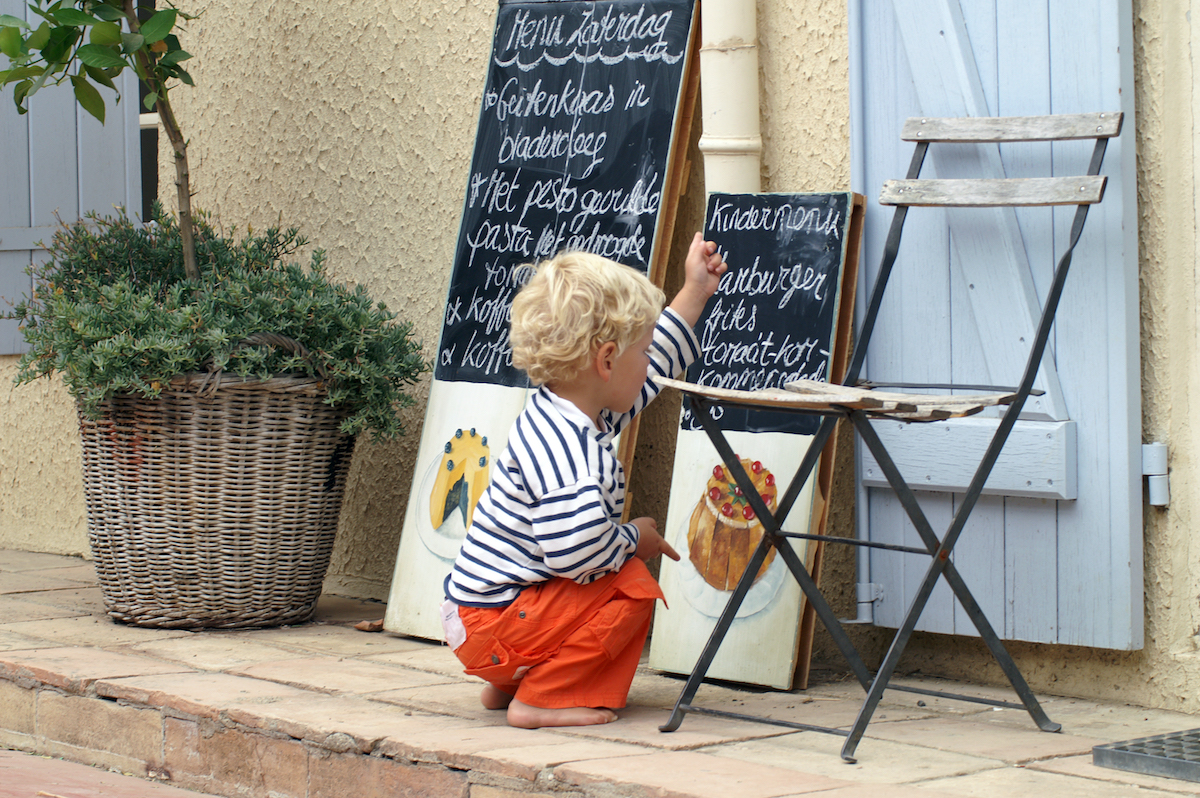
[{"left": 851, "top": 0, "right": 1144, "bottom": 649}]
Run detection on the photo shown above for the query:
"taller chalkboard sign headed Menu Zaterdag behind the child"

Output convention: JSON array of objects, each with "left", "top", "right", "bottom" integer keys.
[{"left": 384, "top": 0, "right": 694, "bottom": 638}]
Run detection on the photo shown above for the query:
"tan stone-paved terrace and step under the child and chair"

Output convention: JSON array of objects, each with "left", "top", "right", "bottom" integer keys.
[{"left": 0, "top": 551, "right": 1200, "bottom": 798}]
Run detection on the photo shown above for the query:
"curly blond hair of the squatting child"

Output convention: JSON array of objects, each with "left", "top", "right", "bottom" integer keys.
[{"left": 510, "top": 252, "right": 666, "bottom": 385}]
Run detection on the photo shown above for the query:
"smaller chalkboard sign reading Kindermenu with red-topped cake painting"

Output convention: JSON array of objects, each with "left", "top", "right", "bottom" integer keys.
[{"left": 649, "top": 193, "right": 857, "bottom": 689}]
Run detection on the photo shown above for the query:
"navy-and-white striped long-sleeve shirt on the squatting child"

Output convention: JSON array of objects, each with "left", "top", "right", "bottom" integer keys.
[{"left": 445, "top": 310, "right": 700, "bottom": 607}]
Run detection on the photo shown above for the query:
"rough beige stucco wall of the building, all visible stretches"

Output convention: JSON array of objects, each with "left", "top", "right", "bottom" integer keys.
[{"left": 0, "top": 0, "right": 1200, "bottom": 710}]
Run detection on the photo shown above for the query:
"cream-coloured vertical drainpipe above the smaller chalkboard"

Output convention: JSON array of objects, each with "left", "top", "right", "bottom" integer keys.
[{"left": 700, "top": 0, "right": 762, "bottom": 193}]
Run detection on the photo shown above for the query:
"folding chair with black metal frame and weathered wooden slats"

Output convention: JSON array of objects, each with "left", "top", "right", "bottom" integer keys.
[{"left": 660, "top": 113, "right": 1122, "bottom": 762}]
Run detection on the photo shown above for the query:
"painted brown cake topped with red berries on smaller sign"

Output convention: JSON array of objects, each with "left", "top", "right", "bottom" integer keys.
[{"left": 688, "top": 457, "right": 776, "bottom": 590}]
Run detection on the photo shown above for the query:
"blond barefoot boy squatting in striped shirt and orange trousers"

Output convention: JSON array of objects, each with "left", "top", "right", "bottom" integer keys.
[{"left": 442, "top": 233, "right": 726, "bottom": 728}]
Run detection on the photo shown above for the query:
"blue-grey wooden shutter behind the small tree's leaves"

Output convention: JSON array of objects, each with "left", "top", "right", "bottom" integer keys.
[{"left": 0, "top": 0, "right": 142, "bottom": 354}]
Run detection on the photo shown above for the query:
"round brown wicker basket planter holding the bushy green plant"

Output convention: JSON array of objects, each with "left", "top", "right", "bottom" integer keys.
[{"left": 79, "top": 373, "right": 354, "bottom": 629}]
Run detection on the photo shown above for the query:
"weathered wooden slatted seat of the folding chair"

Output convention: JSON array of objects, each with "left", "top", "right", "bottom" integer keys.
[{"left": 654, "top": 377, "right": 1016, "bottom": 421}]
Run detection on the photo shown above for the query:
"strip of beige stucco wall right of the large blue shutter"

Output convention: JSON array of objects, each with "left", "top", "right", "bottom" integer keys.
[{"left": 1135, "top": 0, "right": 1200, "bottom": 710}]
